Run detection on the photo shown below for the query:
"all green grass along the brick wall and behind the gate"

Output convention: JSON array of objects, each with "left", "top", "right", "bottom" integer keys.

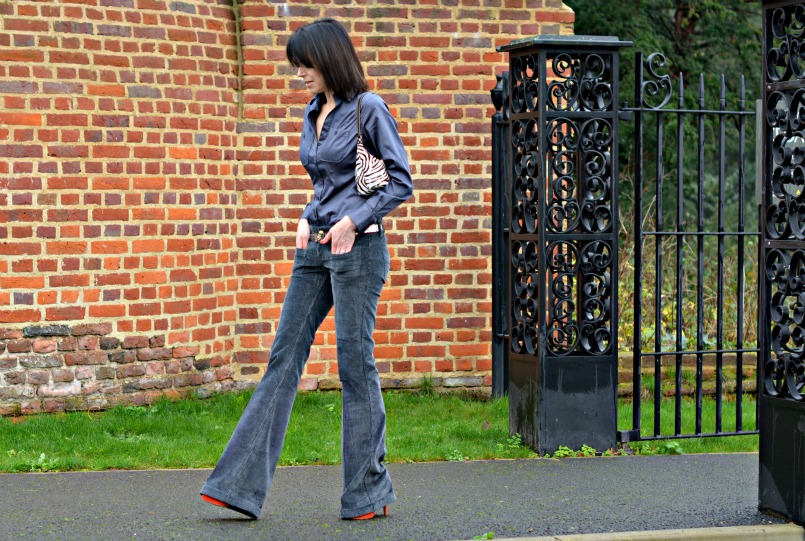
[{"left": 0, "top": 392, "right": 757, "bottom": 472}]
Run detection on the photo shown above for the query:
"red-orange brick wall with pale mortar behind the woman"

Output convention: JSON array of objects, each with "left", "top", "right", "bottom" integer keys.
[{"left": 0, "top": 0, "right": 573, "bottom": 411}]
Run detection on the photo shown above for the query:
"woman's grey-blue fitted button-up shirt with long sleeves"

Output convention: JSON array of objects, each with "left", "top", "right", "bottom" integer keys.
[{"left": 299, "top": 92, "right": 414, "bottom": 231}]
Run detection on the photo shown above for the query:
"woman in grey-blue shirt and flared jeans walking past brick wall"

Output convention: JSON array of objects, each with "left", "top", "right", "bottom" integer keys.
[{"left": 201, "top": 19, "right": 413, "bottom": 520}]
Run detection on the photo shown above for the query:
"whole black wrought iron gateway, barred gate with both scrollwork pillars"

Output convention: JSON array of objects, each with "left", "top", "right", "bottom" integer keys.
[{"left": 492, "top": 0, "right": 805, "bottom": 524}]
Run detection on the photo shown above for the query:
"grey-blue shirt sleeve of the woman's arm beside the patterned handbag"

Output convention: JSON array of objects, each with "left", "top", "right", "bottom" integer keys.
[{"left": 349, "top": 93, "right": 414, "bottom": 231}]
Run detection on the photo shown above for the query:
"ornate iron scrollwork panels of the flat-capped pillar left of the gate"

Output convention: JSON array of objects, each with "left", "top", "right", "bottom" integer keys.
[{"left": 510, "top": 47, "right": 617, "bottom": 356}]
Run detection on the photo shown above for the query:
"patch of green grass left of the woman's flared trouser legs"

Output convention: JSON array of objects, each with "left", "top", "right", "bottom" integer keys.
[{"left": 0, "top": 393, "right": 254, "bottom": 471}]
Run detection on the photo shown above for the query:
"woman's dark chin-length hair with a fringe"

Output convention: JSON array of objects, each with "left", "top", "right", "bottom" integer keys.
[{"left": 285, "top": 18, "right": 369, "bottom": 100}]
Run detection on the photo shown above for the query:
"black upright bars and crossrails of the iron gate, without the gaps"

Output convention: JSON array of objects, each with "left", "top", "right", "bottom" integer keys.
[{"left": 620, "top": 52, "right": 760, "bottom": 442}]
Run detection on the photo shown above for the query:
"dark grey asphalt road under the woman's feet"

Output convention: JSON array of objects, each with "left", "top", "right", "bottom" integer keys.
[{"left": 0, "top": 454, "right": 782, "bottom": 541}]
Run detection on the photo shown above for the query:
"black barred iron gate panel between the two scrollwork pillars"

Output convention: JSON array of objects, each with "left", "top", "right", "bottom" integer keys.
[{"left": 619, "top": 52, "right": 759, "bottom": 442}]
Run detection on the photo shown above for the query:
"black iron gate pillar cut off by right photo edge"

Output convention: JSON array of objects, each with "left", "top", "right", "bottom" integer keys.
[{"left": 758, "top": 0, "right": 805, "bottom": 524}]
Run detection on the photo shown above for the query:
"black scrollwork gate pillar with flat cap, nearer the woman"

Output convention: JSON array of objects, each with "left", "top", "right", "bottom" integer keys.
[{"left": 495, "top": 35, "right": 631, "bottom": 453}]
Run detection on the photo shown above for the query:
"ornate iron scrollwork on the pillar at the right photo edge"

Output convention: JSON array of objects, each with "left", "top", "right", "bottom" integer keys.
[{"left": 762, "top": 4, "right": 805, "bottom": 401}]
